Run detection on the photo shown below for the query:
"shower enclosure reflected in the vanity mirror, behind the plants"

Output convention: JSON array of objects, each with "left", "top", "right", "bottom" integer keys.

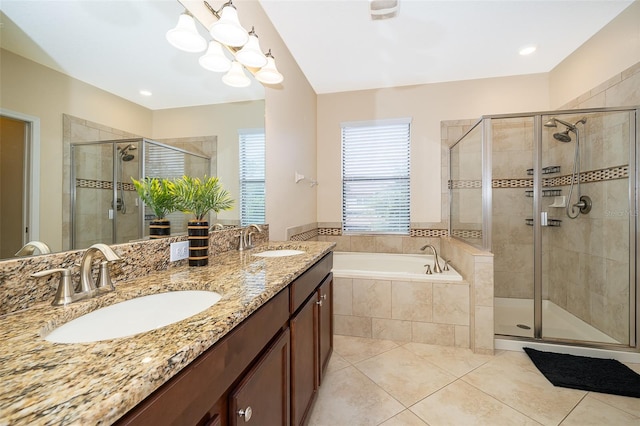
[{"left": 70, "top": 138, "right": 211, "bottom": 249}]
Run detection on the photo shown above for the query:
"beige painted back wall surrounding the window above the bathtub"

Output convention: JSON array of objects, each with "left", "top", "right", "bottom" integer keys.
[{"left": 317, "top": 74, "right": 549, "bottom": 222}]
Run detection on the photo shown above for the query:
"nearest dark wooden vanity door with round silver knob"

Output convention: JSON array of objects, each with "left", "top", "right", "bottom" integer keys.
[{"left": 229, "top": 329, "right": 290, "bottom": 426}]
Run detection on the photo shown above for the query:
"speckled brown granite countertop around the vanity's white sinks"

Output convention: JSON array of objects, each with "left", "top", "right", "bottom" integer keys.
[{"left": 0, "top": 241, "right": 334, "bottom": 425}]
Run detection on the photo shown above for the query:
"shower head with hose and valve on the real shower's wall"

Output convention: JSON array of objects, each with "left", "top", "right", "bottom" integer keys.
[{"left": 544, "top": 117, "right": 592, "bottom": 219}]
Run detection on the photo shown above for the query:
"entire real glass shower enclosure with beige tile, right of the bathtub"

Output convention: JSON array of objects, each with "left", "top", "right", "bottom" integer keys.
[{"left": 449, "top": 108, "right": 640, "bottom": 350}]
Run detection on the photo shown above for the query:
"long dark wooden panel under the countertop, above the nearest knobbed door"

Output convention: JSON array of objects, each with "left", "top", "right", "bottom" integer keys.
[{"left": 116, "top": 288, "right": 289, "bottom": 426}]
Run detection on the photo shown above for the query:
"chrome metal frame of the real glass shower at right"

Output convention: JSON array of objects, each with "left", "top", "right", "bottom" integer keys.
[{"left": 449, "top": 106, "right": 640, "bottom": 353}]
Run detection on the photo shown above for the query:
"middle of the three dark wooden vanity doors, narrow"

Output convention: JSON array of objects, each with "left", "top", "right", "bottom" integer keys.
[{"left": 289, "top": 291, "right": 319, "bottom": 426}]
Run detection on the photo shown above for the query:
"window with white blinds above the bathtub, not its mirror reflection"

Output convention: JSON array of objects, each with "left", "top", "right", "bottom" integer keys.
[{"left": 342, "top": 119, "right": 411, "bottom": 235}]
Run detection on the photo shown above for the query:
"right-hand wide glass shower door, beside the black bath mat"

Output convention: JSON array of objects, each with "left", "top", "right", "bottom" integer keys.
[{"left": 535, "top": 111, "right": 636, "bottom": 346}]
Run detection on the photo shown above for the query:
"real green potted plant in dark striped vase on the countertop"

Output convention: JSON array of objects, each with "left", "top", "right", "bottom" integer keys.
[{"left": 171, "top": 176, "right": 233, "bottom": 266}]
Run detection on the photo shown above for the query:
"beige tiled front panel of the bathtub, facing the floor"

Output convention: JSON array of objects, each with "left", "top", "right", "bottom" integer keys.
[{"left": 333, "top": 277, "right": 469, "bottom": 348}]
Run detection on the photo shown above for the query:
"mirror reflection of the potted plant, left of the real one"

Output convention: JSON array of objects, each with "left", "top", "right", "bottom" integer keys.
[{"left": 131, "top": 177, "right": 175, "bottom": 238}]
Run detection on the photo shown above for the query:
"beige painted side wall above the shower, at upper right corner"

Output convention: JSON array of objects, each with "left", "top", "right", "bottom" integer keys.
[{"left": 549, "top": 0, "right": 640, "bottom": 109}]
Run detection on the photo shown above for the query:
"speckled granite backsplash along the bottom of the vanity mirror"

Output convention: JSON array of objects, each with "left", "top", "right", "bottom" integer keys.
[{"left": 0, "top": 225, "right": 269, "bottom": 315}]
